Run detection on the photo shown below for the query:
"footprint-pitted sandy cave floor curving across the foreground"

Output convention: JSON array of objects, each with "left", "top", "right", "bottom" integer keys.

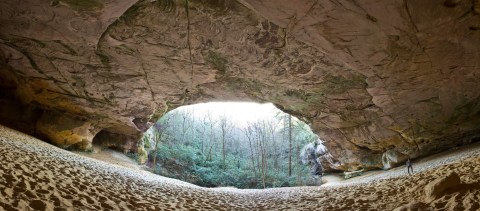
[{"left": 0, "top": 126, "right": 480, "bottom": 210}]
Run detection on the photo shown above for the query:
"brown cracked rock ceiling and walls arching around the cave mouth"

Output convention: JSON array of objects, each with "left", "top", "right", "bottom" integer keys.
[{"left": 0, "top": 0, "right": 480, "bottom": 170}]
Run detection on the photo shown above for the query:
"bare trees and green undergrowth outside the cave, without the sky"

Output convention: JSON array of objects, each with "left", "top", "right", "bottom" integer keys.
[{"left": 141, "top": 104, "right": 318, "bottom": 188}]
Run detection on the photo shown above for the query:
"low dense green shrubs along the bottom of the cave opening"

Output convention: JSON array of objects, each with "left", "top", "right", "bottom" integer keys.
[{"left": 157, "top": 144, "right": 282, "bottom": 188}]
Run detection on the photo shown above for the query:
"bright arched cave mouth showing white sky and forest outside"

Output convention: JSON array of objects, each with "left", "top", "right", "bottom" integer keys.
[{"left": 142, "top": 102, "right": 323, "bottom": 189}]
